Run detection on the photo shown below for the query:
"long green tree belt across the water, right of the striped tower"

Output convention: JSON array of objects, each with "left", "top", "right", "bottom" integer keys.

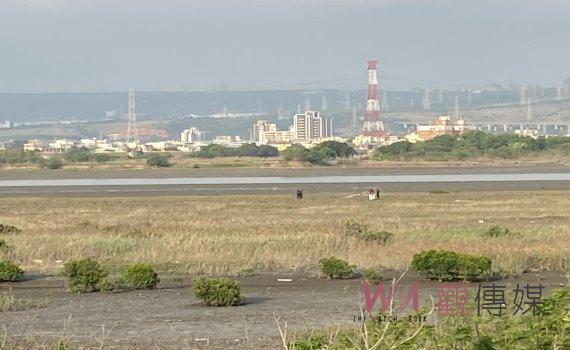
[{"left": 374, "top": 131, "right": 570, "bottom": 160}]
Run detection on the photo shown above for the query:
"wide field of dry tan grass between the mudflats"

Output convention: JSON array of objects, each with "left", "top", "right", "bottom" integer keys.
[{"left": 0, "top": 191, "right": 570, "bottom": 275}]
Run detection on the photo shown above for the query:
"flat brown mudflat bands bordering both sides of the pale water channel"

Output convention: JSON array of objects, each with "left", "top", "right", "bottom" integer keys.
[{"left": 0, "top": 165, "right": 570, "bottom": 197}]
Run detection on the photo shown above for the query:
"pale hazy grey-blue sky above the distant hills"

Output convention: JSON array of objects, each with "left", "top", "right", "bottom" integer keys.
[{"left": 0, "top": 0, "right": 570, "bottom": 92}]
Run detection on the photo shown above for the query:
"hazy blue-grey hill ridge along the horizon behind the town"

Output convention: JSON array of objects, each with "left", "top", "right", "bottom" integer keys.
[{"left": 0, "top": 89, "right": 536, "bottom": 122}]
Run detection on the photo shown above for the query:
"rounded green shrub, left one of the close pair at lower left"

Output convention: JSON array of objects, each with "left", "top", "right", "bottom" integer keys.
[{"left": 63, "top": 259, "right": 107, "bottom": 293}]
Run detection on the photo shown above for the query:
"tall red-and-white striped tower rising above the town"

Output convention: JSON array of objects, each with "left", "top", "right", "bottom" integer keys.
[{"left": 362, "top": 60, "right": 384, "bottom": 137}]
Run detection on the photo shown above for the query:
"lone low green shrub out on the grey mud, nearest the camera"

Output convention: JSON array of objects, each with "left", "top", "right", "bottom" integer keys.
[{"left": 193, "top": 277, "right": 244, "bottom": 306}]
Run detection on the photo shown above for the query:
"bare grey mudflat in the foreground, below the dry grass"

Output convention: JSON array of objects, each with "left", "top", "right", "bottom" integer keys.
[{"left": 0, "top": 272, "right": 566, "bottom": 349}]
